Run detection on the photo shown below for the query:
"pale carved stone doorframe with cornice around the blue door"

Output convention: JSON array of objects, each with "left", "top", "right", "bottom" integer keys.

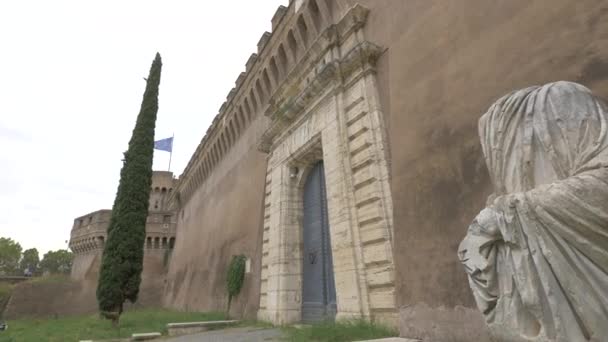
[{"left": 258, "top": 6, "right": 397, "bottom": 324}]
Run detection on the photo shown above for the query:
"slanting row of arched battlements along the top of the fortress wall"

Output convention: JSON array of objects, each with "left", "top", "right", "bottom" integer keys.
[{"left": 169, "top": 0, "right": 336, "bottom": 207}]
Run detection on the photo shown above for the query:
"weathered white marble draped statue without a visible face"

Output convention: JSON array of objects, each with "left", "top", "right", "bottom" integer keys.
[{"left": 459, "top": 82, "right": 608, "bottom": 342}]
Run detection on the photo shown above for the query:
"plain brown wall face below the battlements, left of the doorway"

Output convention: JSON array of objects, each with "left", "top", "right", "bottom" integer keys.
[{"left": 164, "top": 116, "right": 266, "bottom": 318}]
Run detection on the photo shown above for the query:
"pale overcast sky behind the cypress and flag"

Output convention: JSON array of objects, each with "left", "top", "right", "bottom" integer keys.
[{"left": 0, "top": 0, "right": 288, "bottom": 256}]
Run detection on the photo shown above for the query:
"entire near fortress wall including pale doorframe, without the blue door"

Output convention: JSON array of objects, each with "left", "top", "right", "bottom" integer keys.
[{"left": 60, "top": 0, "right": 608, "bottom": 341}]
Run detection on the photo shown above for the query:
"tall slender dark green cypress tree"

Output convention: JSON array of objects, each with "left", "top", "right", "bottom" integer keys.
[{"left": 97, "top": 53, "right": 162, "bottom": 324}]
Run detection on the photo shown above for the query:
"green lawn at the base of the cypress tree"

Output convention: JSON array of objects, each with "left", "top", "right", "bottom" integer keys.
[{"left": 0, "top": 310, "right": 225, "bottom": 342}]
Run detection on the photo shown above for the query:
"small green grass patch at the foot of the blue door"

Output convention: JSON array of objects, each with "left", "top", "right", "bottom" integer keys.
[{"left": 283, "top": 320, "right": 399, "bottom": 342}]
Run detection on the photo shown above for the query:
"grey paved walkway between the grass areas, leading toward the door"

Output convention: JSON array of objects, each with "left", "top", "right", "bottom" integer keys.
[{"left": 164, "top": 327, "right": 282, "bottom": 342}]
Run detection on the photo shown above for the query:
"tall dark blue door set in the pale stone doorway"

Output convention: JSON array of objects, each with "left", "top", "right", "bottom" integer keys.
[{"left": 302, "top": 161, "right": 336, "bottom": 322}]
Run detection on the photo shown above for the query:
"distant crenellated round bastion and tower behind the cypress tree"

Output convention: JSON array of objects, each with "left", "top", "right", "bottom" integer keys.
[{"left": 64, "top": 171, "right": 176, "bottom": 317}]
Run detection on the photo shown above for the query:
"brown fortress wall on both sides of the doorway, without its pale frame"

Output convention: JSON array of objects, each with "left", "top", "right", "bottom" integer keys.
[{"left": 165, "top": 0, "right": 608, "bottom": 341}]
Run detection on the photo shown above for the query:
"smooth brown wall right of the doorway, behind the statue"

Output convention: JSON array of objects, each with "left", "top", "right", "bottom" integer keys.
[{"left": 338, "top": 0, "right": 608, "bottom": 341}]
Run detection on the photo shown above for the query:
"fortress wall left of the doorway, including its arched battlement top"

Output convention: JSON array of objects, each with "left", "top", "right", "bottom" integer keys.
[{"left": 165, "top": 1, "right": 378, "bottom": 323}]
